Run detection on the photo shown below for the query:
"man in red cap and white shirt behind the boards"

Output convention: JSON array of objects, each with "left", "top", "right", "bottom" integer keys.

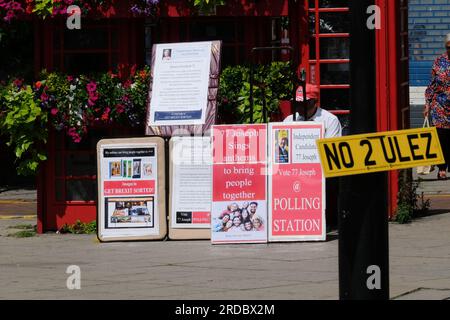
[{"left": 284, "top": 83, "right": 342, "bottom": 138}]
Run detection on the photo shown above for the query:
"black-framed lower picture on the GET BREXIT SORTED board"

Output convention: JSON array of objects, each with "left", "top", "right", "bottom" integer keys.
[{"left": 105, "top": 197, "right": 154, "bottom": 229}]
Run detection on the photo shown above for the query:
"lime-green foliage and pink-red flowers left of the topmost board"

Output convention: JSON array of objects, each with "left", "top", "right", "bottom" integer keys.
[{"left": 0, "top": 66, "right": 150, "bottom": 175}]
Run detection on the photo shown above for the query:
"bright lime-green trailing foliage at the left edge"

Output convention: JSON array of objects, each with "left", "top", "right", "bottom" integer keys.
[{"left": 0, "top": 83, "right": 47, "bottom": 175}]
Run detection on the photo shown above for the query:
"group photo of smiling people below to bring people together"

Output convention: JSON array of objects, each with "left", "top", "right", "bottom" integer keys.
[{"left": 212, "top": 201, "right": 265, "bottom": 233}]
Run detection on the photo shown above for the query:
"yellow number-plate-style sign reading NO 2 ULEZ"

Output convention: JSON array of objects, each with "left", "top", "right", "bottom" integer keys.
[{"left": 317, "top": 127, "right": 444, "bottom": 178}]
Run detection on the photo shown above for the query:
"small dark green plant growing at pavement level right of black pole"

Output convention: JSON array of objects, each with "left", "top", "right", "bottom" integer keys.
[{"left": 394, "top": 170, "right": 431, "bottom": 224}]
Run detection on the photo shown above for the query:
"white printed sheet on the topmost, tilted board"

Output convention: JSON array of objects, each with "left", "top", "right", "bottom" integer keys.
[{"left": 149, "top": 42, "right": 212, "bottom": 126}]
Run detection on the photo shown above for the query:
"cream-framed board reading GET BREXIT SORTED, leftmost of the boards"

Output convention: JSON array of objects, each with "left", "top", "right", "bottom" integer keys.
[{"left": 97, "top": 137, "right": 167, "bottom": 241}]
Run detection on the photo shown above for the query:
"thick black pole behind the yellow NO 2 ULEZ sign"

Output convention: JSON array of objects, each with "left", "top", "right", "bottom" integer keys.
[{"left": 339, "top": 0, "right": 389, "bottom": 300}]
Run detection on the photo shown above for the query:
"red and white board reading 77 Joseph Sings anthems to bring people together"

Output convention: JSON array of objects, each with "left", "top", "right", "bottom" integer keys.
[{"left": 211, "top": 124, "right": 268, "bottom": 244}]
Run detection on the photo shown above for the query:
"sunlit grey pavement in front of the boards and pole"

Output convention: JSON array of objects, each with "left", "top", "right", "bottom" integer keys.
[{"left": 0, "top": 174, "right": 450, "bottom": 300}]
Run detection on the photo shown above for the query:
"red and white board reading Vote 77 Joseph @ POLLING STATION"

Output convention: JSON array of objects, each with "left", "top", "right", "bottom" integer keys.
[{"left": 269, "top": 122, "right": 326, "bottom": 241}]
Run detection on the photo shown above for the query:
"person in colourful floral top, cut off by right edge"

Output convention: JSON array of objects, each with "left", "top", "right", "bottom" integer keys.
[{"left": 423, "top": 33, "right": 450, "bottom": 180}]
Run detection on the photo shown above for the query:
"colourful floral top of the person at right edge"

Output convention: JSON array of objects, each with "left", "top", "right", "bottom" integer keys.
[{"left": 425, "top": 53, "right": 450, "bottom": 129}]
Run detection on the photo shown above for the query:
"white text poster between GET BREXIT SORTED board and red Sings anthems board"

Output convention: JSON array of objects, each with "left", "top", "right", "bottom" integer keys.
[{"left": 171, "top": 137, "right": 212, "bottom": 229}]
